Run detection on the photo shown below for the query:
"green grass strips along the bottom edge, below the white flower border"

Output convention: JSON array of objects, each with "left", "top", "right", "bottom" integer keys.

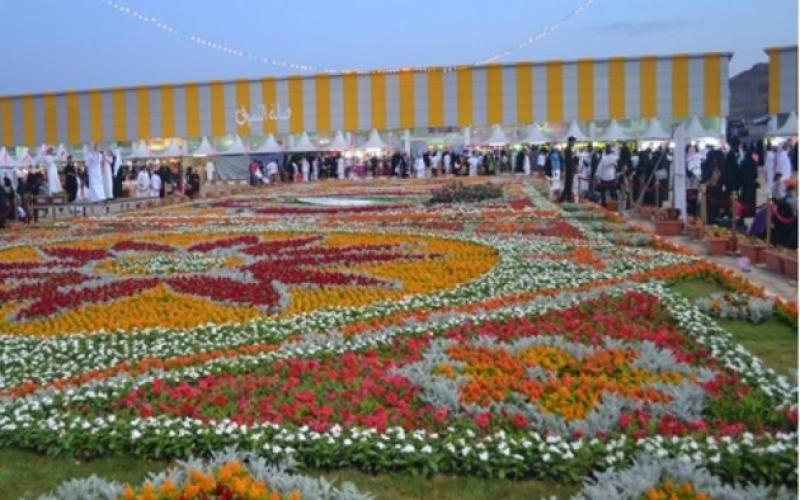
[{"left": 0, "top": 450, "right": 579, "bottom": 500}]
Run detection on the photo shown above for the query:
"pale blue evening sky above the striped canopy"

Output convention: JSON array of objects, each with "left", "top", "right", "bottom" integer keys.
[{"left": 0, "top": 0, "right": 798, "bottom": 95}]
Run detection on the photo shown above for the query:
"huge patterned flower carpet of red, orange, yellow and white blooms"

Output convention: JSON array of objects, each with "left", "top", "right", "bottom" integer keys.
[{"left": 0, "top": 177, "right": 797, "bottom": 498}]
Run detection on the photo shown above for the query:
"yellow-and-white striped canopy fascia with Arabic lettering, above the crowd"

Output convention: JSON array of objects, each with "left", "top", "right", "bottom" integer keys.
[{"left": 0, "top": 52, "right": 732, "bottom": 146}]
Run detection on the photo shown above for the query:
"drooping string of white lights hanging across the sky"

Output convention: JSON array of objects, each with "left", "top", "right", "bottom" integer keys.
[{"left": 100, "top": 0, "right": 594, "bottom": 74}]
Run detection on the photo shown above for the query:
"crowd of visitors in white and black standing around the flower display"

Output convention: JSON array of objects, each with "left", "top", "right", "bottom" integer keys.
[{"left": 0, "top": 137, "right": 797, "bottom": 247}]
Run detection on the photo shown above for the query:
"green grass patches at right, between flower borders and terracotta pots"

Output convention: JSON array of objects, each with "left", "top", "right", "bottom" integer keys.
[{"left": 670, "top": 280, "right": 797, "bottom": 375}]
